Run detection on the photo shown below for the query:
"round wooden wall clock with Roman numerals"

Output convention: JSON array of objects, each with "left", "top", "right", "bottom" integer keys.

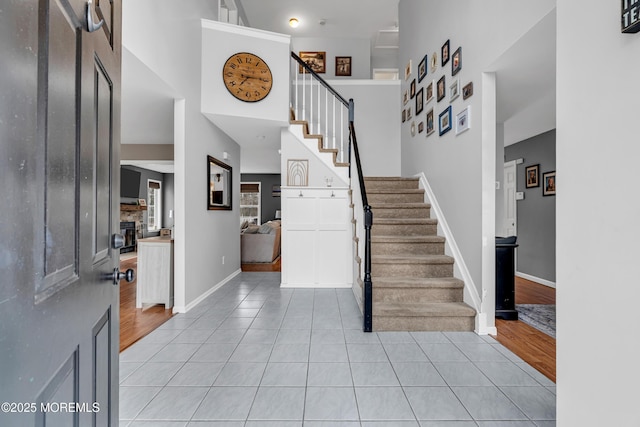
[{"left": 222, "top": 52, "right": 273, "bottom": 102}]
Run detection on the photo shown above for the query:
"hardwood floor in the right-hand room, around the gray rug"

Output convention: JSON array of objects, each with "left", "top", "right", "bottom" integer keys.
[{"left": 494, "top": 277, "right": 556, "bottom": 382}]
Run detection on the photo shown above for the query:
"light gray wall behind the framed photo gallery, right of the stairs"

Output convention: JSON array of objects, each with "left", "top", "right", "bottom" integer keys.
[{"left": 397, "top": 0, "right": 555, "bottom": 308}]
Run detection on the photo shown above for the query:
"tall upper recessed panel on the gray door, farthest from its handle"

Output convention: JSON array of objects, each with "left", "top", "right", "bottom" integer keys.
[{"left": 37, "top": 0, "right": 82, "bottom": 301}]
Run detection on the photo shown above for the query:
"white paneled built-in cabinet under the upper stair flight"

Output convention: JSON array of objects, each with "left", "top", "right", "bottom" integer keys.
[{"left": 281, "top": 187, "right": 353, "bottom": 288}]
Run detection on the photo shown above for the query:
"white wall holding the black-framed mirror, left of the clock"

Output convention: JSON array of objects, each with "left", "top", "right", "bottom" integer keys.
[{"left": 123, "top": 0, "right": 240, "bottom": 310}]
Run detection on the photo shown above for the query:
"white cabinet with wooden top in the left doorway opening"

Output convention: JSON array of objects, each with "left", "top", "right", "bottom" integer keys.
[{"left": 136, "top": 236, "right": 173, "bottom": 309}]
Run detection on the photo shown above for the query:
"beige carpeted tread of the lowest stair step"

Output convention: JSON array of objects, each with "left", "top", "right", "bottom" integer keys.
[{"left": 373, "top": 302, "right": 476, "bottom": 317}]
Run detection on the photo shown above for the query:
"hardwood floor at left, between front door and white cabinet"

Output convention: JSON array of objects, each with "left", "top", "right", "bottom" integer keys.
[{"left": 120, "top": 257, "right": 173, "bottom": 351}]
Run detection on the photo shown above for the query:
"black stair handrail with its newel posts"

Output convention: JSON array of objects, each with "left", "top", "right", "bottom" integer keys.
[{"left": 291, "top": 52, "right": 373, "bottom": 332}]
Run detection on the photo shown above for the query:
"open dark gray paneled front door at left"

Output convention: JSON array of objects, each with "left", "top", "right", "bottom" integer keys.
[{"left": 0, "top": 0, "right": 121, "bottom": 427}]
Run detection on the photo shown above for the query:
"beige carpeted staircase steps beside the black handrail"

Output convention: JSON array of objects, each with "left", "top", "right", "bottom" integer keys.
[{"left": 365, "top": 177, "right": 476, "bottom": 331}]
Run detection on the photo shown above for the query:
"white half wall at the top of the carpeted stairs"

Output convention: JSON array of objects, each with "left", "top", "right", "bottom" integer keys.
[{"left": 329, "top": 80, "right": 401, "bottom": 176}]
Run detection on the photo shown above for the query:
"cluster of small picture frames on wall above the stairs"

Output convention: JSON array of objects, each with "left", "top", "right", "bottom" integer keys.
[{"left": 401, "top": 39, "right": 473, "bottom": 137}]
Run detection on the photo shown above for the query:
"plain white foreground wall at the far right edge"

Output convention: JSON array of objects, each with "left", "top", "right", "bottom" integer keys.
[{"left": 556, "top": 0, "right": 640, "bottom": 427}]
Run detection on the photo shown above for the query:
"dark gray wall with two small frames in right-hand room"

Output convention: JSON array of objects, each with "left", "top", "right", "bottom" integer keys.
[{"left": 504, "top": 130, "right": 562, "bottom": 282}]
